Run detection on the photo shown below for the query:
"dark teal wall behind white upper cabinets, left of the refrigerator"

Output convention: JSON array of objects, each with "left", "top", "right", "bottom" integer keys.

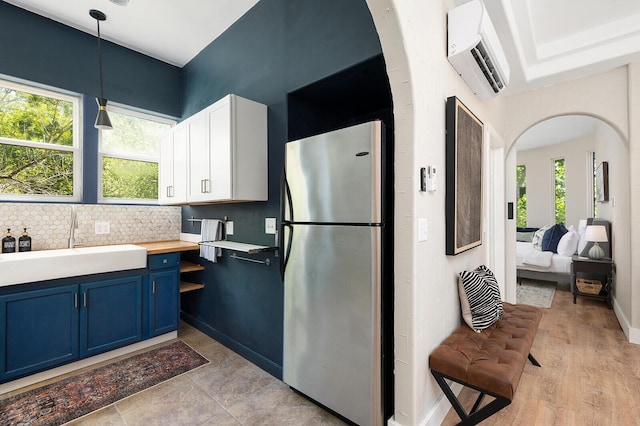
[{"left": 176, "top": 0, "right": 386, "bottom": 377}]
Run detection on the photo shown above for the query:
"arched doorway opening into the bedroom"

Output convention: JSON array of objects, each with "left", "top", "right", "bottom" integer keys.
[{"left": 506, "top": 114, "right": 631, "bottom": 316}]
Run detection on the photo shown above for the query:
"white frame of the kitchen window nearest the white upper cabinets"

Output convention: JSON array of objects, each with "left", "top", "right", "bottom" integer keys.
[{"left": 97, "top": 102, "right": 177, "bottom": 205}]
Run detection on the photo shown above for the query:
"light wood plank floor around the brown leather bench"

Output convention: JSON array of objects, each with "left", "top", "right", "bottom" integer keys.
[{"left": 442, "top": 291, "right": 640, "bottom": 426}]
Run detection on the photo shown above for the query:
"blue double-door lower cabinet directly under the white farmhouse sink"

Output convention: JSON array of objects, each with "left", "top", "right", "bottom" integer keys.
[{"left": 0, "top": 270, "right": 145, "bottom": 383}]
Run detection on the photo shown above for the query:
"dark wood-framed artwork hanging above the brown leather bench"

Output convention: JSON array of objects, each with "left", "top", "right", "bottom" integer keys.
[{"left": 445, "top": 96, "right": 484, "bottom": 255}]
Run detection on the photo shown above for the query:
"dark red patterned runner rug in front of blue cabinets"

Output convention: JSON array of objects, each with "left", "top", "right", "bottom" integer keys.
[{"left": 0, "top": 341, "right": 209, "bottom": 426}]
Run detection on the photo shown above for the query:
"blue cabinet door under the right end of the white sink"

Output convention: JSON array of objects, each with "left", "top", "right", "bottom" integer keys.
[{"left": 80, "top": 275, "right": 142, "bottom": 357}]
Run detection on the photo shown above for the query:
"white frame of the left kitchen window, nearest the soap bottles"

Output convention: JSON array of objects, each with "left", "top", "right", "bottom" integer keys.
[{"left": 0, "top": 75, "right": 83, "bottom": 202}]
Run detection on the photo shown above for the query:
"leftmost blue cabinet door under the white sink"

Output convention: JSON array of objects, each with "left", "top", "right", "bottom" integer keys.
[{"left": 0, "top": 285, "right": 78, "bottom": 382}]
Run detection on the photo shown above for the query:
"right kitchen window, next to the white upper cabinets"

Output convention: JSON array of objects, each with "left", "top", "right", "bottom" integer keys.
[{"left": 98, "top": 107, "right": 175, "bottom": 203}]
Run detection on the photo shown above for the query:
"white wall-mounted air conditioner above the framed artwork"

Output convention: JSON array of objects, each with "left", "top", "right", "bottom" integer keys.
[{"left": 448, "top": 0, "right": 510, "bottom": 99}]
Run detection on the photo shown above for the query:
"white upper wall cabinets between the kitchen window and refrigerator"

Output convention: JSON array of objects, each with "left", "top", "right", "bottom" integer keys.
[{"left": 160, "top": 95, "right": 268, "bottom": 204}]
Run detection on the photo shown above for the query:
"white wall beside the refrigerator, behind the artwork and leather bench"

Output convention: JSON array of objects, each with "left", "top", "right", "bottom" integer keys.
[{"left": 367, "top": 0, "right": 504, "bottom": 425}]
